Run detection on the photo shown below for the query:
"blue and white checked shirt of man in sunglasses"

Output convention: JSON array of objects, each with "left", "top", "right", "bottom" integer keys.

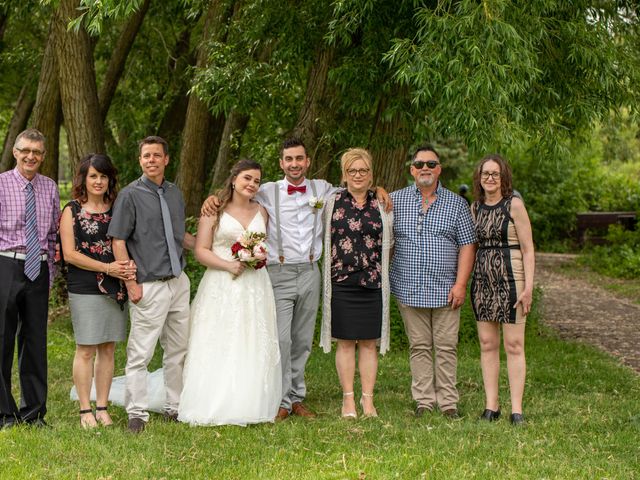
[{"left": 390, "top": 183, "right": 476, "bottom": 308}]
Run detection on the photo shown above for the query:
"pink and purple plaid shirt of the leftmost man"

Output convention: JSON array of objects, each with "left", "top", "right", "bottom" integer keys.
[{"left": 0, "top": 168, "right": 60, "bottom": 282}]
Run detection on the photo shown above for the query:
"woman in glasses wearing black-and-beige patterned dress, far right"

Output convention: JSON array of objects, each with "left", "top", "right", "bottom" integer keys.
[{"left": 471, "top": 155, "right": 535, "bottom": 424}]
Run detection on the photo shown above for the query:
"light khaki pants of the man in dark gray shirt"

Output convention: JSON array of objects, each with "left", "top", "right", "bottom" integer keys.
[{"left": 124, "top": 272, "right": 189, "bottom": 422}]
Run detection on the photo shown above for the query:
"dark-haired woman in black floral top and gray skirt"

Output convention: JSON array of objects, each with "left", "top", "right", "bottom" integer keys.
[{"left": 60, "top": 154, "right": 135, "bottom": 428}]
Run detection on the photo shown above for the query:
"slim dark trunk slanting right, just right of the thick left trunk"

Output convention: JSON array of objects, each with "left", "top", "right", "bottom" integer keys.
[{"left": 98, "top": 0, "right": 150, "bottom": 122}]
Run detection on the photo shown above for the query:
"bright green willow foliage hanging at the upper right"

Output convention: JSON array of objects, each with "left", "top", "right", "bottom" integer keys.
[{"left": 384, "top": 0, "right": 640, "bottom": 173}]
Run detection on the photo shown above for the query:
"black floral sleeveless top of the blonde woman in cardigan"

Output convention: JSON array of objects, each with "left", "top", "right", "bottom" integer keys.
[{"left": 331, "top": 190, "right": 382, "bottom": 288}]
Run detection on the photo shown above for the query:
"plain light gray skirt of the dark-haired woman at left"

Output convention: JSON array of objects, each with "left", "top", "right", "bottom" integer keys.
[{"left": 69, "top": 293, "right": 129, "bottom": 345}]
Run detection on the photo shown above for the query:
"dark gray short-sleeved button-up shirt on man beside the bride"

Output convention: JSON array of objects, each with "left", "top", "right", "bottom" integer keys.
[{"left": 108, "top": 176, "right": 185, "bottom": 283}]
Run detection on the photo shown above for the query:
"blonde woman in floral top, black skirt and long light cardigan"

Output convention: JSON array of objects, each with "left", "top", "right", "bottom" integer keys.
[{"left": 320, "top": 148, "right": 393, "bottom": 418}]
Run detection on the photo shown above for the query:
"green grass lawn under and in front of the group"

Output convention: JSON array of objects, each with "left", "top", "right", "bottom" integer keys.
[{"left": 0, "top": 294, "right": 640, "bottom": 479}]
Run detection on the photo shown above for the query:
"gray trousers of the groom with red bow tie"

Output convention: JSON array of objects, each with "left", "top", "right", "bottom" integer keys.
[{"left": 267, "top": 262, "right": 320, "bottom": 410}]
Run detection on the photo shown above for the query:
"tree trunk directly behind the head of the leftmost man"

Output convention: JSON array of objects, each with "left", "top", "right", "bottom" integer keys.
[{"left": 30, "top": 20, "right": 62, "bottom": 181}]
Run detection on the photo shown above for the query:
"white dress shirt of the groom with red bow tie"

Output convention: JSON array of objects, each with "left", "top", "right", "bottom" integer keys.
[{"left": 256, "top": 178, "right": 337, "bottom": 264}]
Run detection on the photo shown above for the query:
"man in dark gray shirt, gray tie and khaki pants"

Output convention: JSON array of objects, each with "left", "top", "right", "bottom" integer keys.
[{"left": 109, "top": 137, "right": 195, "bottom": 433}]
